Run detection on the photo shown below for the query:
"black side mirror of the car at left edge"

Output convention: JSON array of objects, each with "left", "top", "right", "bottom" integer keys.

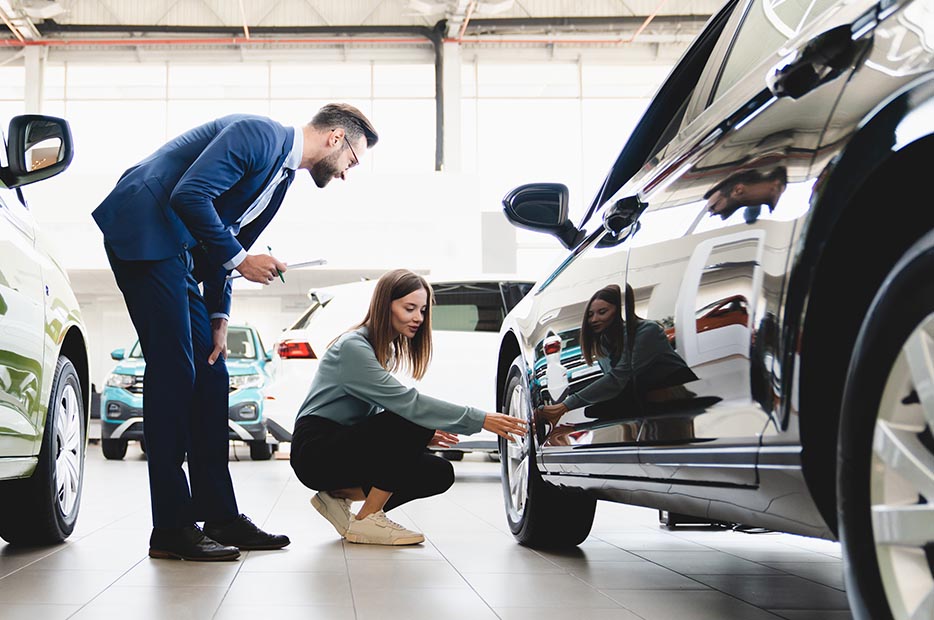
[{"left": 0, "top": 114, "right": 74, "bottom": 188}]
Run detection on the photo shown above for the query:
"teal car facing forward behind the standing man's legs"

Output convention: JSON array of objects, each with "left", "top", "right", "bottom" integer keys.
[{"left": 101, "top": 325, "right": 278, "bottom": 461}]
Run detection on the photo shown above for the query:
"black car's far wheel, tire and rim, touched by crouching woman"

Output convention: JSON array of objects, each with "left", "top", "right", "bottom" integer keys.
[{"left": 499, "top": 358, "right": 597, "bottom": 548}]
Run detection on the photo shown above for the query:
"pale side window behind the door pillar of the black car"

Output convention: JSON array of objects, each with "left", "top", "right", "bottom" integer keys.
[{"left": 714, "top": 0, "right": 836, "bottom": 99}]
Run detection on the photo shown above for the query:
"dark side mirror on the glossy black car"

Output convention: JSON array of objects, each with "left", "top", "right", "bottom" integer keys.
[{"left": 503, "top": 183, "right": 581, "bottom": 249}]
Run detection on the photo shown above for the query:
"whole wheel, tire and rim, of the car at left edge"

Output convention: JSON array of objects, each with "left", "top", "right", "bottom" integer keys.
[{"left": 0, "top": 356, "right": 87, "bottom": 545}]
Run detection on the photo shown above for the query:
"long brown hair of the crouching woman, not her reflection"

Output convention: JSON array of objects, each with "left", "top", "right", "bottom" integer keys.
[{"left": 354, "top": 269, "right": 434, "bottom": 380}]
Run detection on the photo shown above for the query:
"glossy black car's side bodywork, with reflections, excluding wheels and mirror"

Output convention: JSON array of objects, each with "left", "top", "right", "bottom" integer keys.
[{"left": 497, "top": 0, "right": 934, "bottom": 537}]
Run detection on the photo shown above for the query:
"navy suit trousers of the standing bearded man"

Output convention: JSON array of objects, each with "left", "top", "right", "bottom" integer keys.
[{"left": 105, "top": 243, "right": 239, "bottom": 528}]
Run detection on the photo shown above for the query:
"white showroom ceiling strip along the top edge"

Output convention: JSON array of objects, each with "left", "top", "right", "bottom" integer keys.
[{"left": 0, "top": 0, "right": 722, "bottom": 41}]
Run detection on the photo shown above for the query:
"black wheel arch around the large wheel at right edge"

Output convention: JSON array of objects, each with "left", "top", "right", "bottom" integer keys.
[{"left": 782, "top": 79, "right": 934, "bottom": 532}]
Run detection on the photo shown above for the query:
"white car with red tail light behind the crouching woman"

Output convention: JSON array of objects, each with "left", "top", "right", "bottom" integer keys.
[{"left": 266, "top": 278, "right": 533, "bottom": 460}]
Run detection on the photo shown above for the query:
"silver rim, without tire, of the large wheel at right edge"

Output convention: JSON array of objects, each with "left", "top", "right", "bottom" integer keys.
[{"left": 870, "top": 313, "right": 934, "bottom": 620}]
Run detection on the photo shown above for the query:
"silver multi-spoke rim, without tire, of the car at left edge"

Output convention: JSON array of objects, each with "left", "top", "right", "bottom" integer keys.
[{"left": 52, "top": 384, "right": 82, "bottom": 517}]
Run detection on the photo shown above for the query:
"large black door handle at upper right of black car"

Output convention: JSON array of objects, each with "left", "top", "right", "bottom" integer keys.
[{"left": 768, "top": 25, "right": 872, "bottom": 99}]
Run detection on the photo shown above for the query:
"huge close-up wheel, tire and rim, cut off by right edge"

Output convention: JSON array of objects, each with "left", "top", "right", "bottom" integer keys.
[{"left": 837, "top": 232, "right": 934, "bottom": 620}]
